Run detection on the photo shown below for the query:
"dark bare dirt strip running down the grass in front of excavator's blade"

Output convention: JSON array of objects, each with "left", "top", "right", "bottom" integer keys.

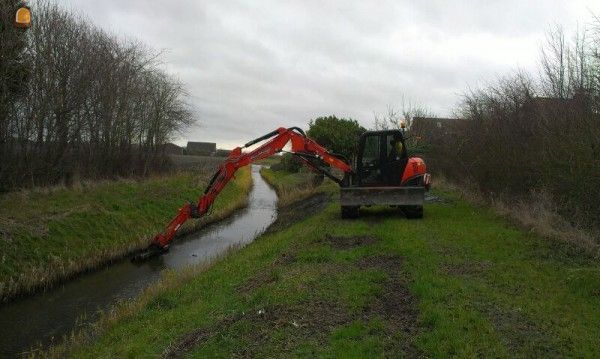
[{"left": 357, "top": 256, "right": 421, "bottom": 358}]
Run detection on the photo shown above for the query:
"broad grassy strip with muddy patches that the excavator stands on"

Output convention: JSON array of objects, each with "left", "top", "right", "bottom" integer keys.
[{"left": 54, "top": 179, "right": 600, "bottom": 358}]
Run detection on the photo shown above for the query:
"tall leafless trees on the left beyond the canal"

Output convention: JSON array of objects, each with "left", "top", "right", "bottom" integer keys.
[{"left": 0, "top": 0, "right": 191, "bottom": 189}]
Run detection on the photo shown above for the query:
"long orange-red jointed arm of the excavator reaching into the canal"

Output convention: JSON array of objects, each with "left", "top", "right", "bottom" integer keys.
[{"left": 133, "top": 127, "right": 352, "bottom": 260}]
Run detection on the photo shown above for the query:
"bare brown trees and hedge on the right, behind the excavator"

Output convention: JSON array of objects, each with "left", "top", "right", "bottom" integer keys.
[{"left": 427, "top": 23, "right": 600, "bottom": 231}]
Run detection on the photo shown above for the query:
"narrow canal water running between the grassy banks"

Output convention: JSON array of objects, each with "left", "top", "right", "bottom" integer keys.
[{"left": 0, "top": 166, "right": 277, "bottom": 358}]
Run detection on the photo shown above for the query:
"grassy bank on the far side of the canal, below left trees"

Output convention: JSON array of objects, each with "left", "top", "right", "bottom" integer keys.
[{"left": 0, "top": 169, "right": 252, "bottom": 299}]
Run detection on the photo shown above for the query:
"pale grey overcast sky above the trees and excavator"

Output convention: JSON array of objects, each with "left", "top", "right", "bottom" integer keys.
[{"left": 50, "top": 0, "right": 600, "bottom": 148}]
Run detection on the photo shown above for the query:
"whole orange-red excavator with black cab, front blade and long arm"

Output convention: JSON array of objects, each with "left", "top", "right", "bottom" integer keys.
[{"left": 133, "top": 127, "right": 431, "bottom": 261}]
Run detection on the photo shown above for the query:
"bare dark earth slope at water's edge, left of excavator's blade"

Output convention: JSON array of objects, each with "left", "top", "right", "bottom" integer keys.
[{"left": 265, "top": 193, "right": 331, "bottom": 233}]
